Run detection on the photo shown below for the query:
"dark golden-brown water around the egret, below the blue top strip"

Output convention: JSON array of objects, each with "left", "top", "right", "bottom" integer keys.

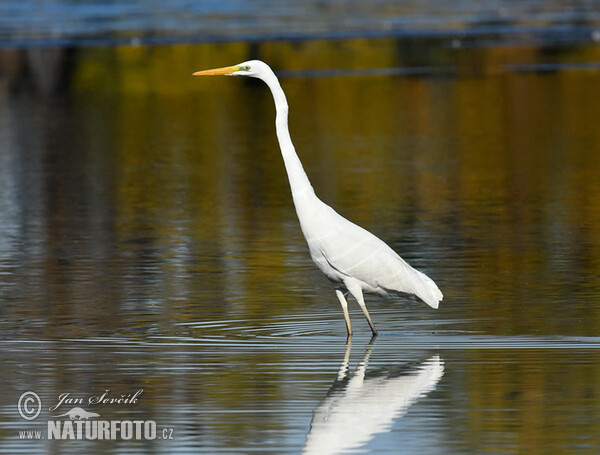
[{"left": 0, "top": 40, "right": 600, "bottom": 453}]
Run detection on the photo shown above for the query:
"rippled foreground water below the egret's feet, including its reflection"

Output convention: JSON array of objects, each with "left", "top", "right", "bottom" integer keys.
[{"left": 2, "top": 330, "right": 600, "bottom": 453}]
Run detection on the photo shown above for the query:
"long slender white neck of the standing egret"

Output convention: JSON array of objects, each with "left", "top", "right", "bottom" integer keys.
[{"left": 262, "top": 71, "right": 314, "bottom": 201}]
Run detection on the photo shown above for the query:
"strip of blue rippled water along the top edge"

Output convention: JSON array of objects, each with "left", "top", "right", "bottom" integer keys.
[{"left": 0, "top": 0, "right": 600, "bottom": 47}]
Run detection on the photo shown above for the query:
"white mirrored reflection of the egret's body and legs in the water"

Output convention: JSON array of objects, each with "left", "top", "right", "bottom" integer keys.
[{"left": 302, "top": 339, "right": 444, "bottom": 454}]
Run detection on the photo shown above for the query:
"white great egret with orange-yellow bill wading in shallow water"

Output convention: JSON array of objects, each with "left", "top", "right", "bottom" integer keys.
[{"left": 194, "top": 60, "right": 443, "bottom": 336}]
